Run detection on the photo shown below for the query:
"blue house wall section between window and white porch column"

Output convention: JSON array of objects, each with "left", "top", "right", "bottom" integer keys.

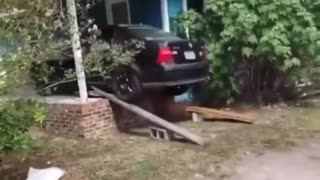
[{"left": 130, "top": 0, "right": 162, "bottom": 28}]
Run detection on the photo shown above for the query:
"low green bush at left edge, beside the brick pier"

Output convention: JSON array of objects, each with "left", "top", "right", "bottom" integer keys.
[{"left": 0, "top": 100, "right": 45, "bottom": 155}]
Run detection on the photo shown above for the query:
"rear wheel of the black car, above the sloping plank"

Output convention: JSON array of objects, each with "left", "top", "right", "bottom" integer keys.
[{"left": 112, "top": 70, "right": 142, "bottom": 101}]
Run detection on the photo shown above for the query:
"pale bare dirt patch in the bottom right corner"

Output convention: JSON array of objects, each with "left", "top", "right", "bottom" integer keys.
[{"left": 231, "top": 142, "right": 320, "bottom": 180}]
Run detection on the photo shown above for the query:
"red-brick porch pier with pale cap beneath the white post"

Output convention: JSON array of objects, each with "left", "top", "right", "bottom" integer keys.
[{"left": 45, "top": 97, "right": 116, "bottom": 139}]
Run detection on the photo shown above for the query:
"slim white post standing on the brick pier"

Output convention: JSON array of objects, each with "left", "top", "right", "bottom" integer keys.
[{"left": 67, "top": 0, "right": 88, "bottom": 103}]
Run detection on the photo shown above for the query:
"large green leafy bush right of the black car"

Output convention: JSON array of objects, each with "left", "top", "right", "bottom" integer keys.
[{"left": 177, "top": 0, "right": 320, "bottom": 103}]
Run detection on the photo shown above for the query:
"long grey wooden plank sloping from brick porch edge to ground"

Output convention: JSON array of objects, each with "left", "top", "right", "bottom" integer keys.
[{"left": 92, "top": 87, "right": 206, "bottom": 145}]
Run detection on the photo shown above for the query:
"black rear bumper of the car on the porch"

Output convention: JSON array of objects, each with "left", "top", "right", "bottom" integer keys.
[{"left": 142, "top": 61, "right": 209, "bottom": 88}]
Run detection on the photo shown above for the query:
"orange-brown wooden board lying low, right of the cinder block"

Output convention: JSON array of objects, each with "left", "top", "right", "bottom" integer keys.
[{"left": 186, "top": 106, "right": 254, "bottom": 123}]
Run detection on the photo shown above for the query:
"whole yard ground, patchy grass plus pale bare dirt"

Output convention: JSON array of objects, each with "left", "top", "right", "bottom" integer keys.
[{"left": 0, "top": 102, "right": 320, "bottom": 180}]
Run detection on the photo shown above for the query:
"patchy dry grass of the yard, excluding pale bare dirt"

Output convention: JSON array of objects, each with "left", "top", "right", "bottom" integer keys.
[{"left": 0, "top": 107, "right": 320, "bottom": 180}]
